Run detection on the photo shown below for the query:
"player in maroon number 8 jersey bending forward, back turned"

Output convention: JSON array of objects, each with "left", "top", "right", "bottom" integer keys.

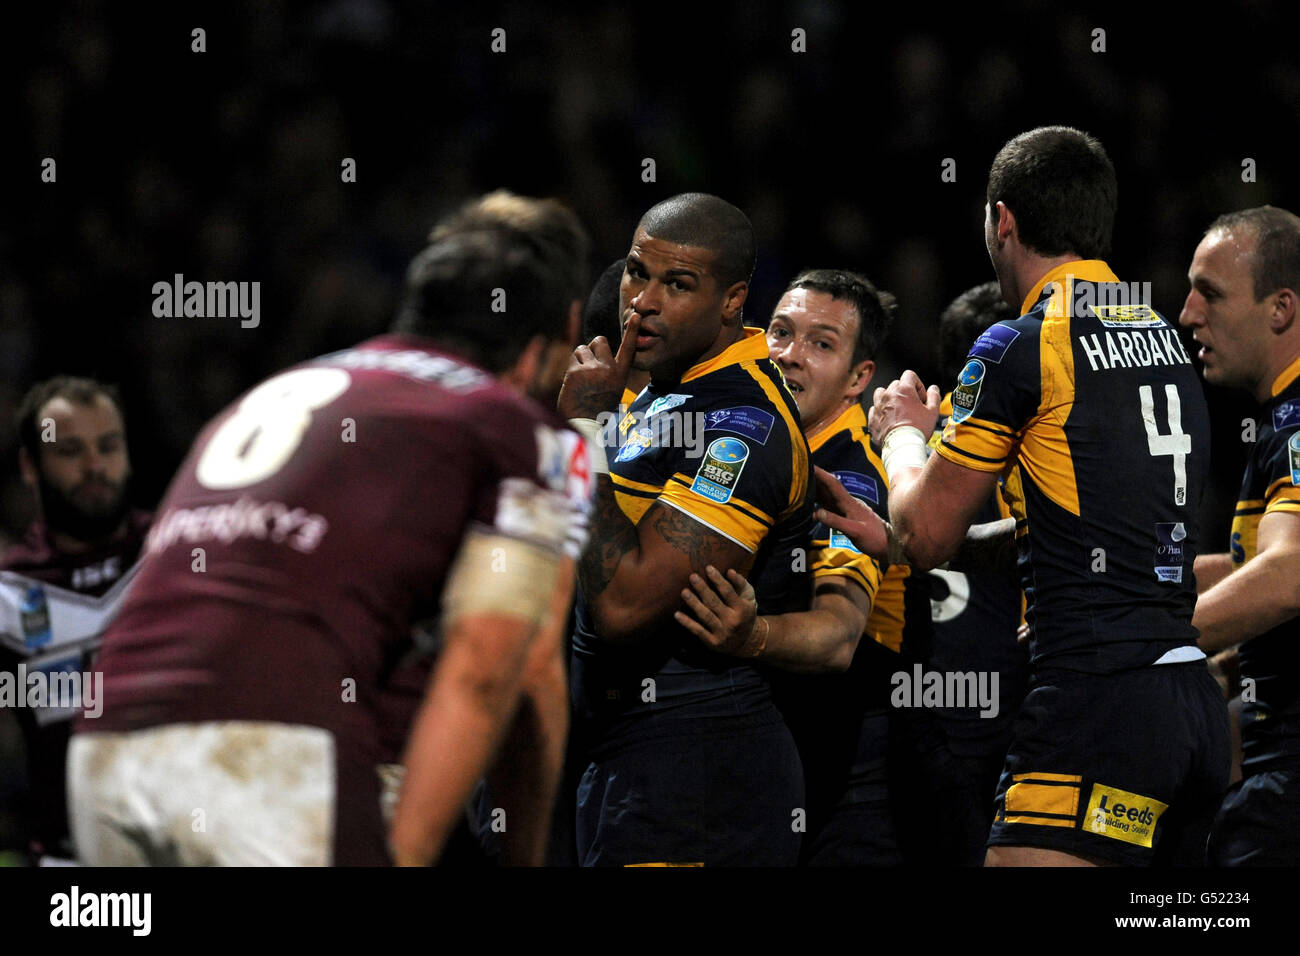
[{"left": 69, "top": 204, "right": 590, "bottom": 865}]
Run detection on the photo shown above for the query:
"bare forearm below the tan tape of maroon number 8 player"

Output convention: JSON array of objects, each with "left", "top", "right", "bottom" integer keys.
[{"left": 389, "top": 618, "right": 530, "bottom": 866}]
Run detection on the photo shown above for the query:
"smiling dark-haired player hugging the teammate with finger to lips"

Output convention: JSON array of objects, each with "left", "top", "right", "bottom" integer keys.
[{"left": 676, "top": 269, "right": 909, "bottom": 866}]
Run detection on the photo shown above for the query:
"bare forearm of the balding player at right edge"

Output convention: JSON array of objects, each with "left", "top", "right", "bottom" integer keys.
[{"left": 1192, "top": 549, "right": 1300, "bottom": 654}]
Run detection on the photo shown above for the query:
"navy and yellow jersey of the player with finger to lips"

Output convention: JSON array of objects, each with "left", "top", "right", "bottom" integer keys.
[{"left": 573, "top": 328, "right": 813, "bottom": 717}]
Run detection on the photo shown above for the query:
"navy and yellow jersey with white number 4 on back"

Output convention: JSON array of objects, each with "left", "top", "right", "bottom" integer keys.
[{"left": 937, "top": 260, "right": 1209, "bottom": 674}]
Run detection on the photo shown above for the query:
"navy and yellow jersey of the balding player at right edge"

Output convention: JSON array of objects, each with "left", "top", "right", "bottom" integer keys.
[{"left": 1231, "top": 359, "right": 1300, "bottom": 773}]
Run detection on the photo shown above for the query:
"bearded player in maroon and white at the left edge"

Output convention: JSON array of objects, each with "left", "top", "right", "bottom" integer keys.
[{"left": 0, "top": 376, "right": 151, "bottom": 858}]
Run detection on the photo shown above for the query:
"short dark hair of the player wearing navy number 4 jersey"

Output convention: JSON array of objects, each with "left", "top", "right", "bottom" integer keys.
[{"left": 988, "top": 126, "right": 1118, "bottom": 259}]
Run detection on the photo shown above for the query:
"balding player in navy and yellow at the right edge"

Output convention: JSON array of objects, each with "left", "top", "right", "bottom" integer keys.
[{"left": 1179, "top": 206, "right": 1300, "bottom": 866}]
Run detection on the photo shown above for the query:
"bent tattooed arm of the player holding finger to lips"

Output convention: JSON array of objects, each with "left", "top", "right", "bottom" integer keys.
[{"left": 579, "top": 475, "right": 754, "bottom": 644}]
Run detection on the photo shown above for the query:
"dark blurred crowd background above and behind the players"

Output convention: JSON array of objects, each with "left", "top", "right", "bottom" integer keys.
[{"left": 0, "top": 0, "right": 1300, "bottom": 550}]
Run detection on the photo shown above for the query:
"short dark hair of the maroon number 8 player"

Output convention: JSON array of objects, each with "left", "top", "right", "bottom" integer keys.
[{"left": 393, "top": 225, "right": 573, "bottom": 372}]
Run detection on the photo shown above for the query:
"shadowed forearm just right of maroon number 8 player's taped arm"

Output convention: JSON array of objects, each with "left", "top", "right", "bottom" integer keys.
[{"left": 488, "top": 662, "right": 569, "bottom": 866}]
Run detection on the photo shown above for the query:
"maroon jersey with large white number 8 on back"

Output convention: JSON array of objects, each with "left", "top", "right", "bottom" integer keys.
[{"left": 91, "top": 336, "right": 592, "bottom": 763}]
